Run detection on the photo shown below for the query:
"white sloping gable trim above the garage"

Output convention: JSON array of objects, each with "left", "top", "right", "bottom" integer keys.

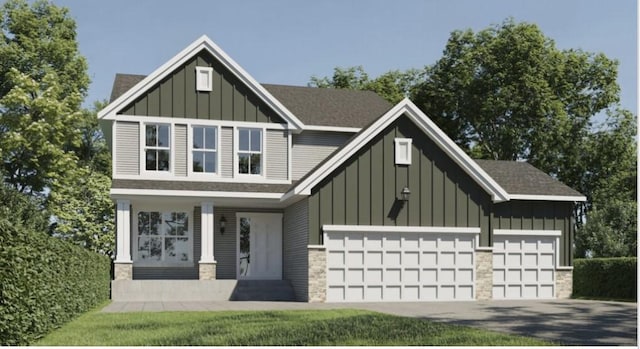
[{"left": 287, "top": 98, "right": 510, "bottom": 202}]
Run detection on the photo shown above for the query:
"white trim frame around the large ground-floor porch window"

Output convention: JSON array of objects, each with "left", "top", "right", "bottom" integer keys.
[{"left": 131, "top": 205, "right": 195, "bottom": 268}]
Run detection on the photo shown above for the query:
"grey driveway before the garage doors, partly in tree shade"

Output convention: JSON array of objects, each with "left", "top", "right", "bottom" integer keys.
[{"left": 355, "top": 300, "right": 638, "bottom": 347}]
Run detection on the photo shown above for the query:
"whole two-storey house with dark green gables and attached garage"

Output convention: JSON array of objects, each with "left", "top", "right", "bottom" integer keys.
[{"left": 98, "top": 36, "right": 585, "bottom": 302}]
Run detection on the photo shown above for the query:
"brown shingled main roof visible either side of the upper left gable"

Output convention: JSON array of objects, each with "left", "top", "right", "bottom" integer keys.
[{"left": 111, "top": 74, "right": 392, "bottom": 128}]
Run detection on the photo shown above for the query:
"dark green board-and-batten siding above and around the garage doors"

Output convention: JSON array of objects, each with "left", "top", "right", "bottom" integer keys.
[{"left": 308, "top": 115, "right": 573, "bottom": 265}]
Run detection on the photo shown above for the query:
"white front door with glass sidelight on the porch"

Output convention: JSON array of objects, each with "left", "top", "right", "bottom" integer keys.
[{"left": 236, "top": 212, "right": 282, "bottom": 280}]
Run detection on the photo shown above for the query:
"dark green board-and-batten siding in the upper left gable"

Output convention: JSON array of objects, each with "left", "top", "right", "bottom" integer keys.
[{"left": 118, "top": 50, "right": 285, "bottom": 123}]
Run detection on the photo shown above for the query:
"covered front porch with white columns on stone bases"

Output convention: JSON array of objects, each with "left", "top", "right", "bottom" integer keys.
[{"left": 112, "top": 193, "right": 295, "bottom": 301}]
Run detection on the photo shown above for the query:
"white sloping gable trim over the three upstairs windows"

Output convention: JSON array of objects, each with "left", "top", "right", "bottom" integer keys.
[{"left": 98, "top": 35, "right": 304, "bottom": 132}]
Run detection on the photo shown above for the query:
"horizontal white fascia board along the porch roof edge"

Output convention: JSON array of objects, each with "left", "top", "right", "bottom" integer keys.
[{"left": 110, "top": 188, "right": 282, "bottom": 198}]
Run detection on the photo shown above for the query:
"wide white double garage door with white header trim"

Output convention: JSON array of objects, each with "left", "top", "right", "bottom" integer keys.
[{"left": 324, "top": 226, "right": 480, "bottom": 302}]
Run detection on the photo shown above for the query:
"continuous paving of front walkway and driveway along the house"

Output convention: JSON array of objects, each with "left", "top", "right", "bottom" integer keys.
[{"left": 102, "top": 300, "right": 638, "bottom": 346}]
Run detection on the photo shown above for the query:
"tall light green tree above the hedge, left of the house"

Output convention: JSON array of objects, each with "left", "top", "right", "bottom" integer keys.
[{"left": 0, "top": 0, "right": 89, "bottom": 194}]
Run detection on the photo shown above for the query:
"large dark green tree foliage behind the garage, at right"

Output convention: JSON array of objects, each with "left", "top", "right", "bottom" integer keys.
[{"left": 310, "top": 19, "right": 637, "bottom": 256}]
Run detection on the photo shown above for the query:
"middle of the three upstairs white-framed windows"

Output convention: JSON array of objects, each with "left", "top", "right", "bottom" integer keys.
[{"left": 191, "top": 126, "right": 218, "bottom": 173}]
